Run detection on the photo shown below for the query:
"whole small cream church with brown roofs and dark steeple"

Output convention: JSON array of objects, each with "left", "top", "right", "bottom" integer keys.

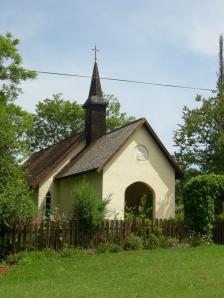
[{"left": 28, "top": 62, "right": 181, "bottom": 219}]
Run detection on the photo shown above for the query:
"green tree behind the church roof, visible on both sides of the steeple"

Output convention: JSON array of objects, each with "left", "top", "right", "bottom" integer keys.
[{"left": 29, "top": 94, "right": 134, "bottom": 151}]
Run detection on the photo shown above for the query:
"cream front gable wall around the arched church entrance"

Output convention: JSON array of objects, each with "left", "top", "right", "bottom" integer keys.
[{"left": 103, "top": 127, "right": 175, "bottom": 219}]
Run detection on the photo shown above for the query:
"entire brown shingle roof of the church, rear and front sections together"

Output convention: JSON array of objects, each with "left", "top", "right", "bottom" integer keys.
[{"left": 26, "top": 118, "right": 182, "bottom": 188}]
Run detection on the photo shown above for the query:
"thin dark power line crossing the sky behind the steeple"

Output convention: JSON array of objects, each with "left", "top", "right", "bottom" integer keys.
[{"left": 26, "top": 70, "right": 217, "bottom": 93}]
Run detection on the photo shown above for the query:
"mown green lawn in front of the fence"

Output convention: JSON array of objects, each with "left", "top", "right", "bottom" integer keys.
[{"left": 0, "top": 245, "right": 224, "bottom": 298}]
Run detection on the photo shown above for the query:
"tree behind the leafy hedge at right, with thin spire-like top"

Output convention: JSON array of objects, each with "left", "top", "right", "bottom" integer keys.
[{"left": 174, "top": 37, "right": 224, "bottom": 174}]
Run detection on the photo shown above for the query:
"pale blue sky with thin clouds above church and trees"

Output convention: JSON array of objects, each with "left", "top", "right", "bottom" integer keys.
[{"left": 0, "top": 0, "right": 224, "bottom": 152}]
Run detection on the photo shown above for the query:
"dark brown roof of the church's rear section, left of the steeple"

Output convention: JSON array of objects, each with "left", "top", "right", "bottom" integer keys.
[{"left": 25, "top": 133, "right": 84, "bottom": 188}]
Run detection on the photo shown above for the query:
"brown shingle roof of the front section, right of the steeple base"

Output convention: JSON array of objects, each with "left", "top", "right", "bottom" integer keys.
[{"left": 56, "top": 119, "right": 181, "bottom": 179}]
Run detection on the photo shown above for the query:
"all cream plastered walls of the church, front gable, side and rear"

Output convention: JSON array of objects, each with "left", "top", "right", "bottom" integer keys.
[{"left": 37, "top": 126, "right": 175, "bottom": 219}]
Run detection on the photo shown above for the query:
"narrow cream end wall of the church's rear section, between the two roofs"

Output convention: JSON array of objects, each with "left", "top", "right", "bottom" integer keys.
[{"left": 38, "top": 140, "right": 85, "bottom": 214}]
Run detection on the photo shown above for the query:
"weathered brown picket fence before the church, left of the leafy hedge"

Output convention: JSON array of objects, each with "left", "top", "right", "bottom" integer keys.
[{"left": 0, "top": 219, "right": 185, "bottom": 254}]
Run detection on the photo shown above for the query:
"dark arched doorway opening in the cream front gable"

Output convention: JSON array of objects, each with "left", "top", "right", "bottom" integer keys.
[{"left": 125, "top": 182, "right": 155, "bottom": 219}]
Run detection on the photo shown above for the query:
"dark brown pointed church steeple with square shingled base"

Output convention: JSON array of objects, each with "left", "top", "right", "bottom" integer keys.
[{"left": 83, "top": 60, "right": 108, "bottom": 145}]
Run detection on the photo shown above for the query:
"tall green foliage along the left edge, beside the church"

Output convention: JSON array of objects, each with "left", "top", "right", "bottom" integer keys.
[{"left": 0, "top": 33, "right": 36, "bottom": 223}]
